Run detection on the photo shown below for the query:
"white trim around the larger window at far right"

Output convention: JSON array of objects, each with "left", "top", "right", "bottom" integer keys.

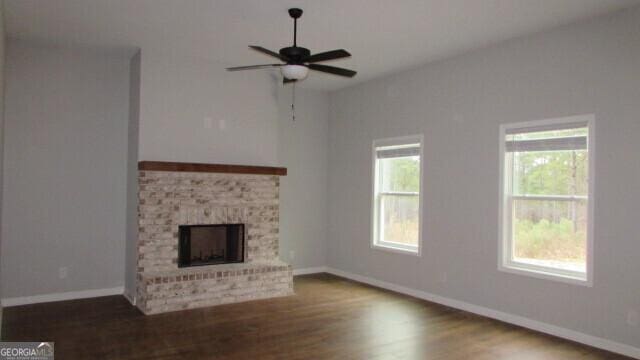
[{"left": 498, "top": 114, "right": 596, "bottom": 287}]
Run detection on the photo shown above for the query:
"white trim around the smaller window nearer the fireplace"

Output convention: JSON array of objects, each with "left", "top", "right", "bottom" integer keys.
[{"left": 369, "top": 134, "right": 424, "bottom": 257}]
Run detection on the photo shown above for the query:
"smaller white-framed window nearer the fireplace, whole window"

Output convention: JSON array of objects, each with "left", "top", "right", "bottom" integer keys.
[{"left": 372, "top": 136, "right": 422, "bottom": 255}]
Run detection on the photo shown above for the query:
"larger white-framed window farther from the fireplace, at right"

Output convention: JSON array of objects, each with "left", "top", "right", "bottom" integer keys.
[{"left": 499, "top": 116, "right": 593, "bottom": 285}]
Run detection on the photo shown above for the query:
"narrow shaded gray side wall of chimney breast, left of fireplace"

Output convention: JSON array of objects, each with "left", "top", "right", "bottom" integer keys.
[{"left": 124, "top": 51, "right": 141, "bottom": 300}]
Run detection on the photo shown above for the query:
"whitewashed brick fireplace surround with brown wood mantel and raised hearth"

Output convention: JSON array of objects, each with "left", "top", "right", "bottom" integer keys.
[{"left": 137, "top": 161, "right": 293, "bottom": 314}]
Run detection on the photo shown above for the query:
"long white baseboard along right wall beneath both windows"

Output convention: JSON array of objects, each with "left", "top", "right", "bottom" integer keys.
[{"left": 326, "top": 267, "right": 640, "bottom": 359}]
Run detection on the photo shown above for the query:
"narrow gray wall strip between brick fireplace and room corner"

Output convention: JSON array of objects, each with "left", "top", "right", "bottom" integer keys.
[{"left": 278, "top": 85, "right": 329, "bottom": 269}]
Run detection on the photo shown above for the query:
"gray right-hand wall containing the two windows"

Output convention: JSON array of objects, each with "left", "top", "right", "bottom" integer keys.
[{"left": 328, "top": 8, "right": 640, "bottom": 347}]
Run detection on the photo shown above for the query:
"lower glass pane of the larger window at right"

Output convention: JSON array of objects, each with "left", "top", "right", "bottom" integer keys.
[{"left": 513, "top": 200, "right": 587, "bottom": 272}]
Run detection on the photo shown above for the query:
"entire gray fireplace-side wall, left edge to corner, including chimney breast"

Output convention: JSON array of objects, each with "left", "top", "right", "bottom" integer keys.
[{"left": 2, "top": 41, "right": 329, "bottom": 304}]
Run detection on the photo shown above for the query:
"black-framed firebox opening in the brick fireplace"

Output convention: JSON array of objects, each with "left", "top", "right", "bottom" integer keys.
[{"left": 178, "top": 224, "right": 245, "bottom": 267}]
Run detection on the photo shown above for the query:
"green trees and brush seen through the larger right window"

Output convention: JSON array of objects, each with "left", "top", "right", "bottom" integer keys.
[{"left": 512, "top": 141, "right": 588, "bottom": 264}]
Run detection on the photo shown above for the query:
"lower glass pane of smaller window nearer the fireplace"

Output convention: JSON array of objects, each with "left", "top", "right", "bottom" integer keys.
[{"left": 380, "top": 194, "right": 419, "bottom": 246}]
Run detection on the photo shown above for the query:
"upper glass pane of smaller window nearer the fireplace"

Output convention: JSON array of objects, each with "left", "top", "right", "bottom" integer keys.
[{"left": 378, "top": 156, "right": 420, "bottom": 192}]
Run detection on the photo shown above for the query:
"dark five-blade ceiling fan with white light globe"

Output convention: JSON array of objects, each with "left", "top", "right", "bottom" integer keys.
[{"left": 227, "top": 8, "right": 356, "bottom": 84}]
